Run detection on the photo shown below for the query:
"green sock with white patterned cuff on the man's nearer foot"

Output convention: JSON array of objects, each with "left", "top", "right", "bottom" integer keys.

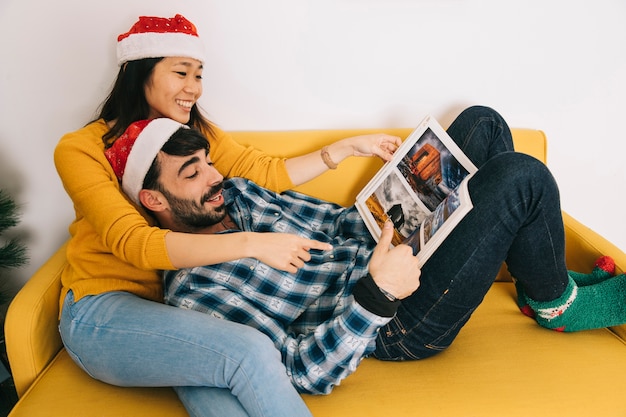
[{"left": 526, "top": 274, "right": 626, "bottom": 332}]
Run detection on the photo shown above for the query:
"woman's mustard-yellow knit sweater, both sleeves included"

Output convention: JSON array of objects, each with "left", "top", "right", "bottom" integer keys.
[{"left": 54, "top": 120, "right": 293, "bottom": 305}]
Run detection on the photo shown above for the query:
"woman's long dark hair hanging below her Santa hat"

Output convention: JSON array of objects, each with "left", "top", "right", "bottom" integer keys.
[{"left": 96, "top": 58, "right": 212, "bottom": 148}]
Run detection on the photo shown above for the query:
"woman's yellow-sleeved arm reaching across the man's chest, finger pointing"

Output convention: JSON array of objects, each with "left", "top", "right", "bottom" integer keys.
[{"left": 54, "top": 122, "right": 328, "bottom": 271}]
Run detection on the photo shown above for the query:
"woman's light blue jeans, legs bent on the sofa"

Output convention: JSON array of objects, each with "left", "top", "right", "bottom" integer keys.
[{"left": 59, "top": 292, "right": 311, "bottom": 417}]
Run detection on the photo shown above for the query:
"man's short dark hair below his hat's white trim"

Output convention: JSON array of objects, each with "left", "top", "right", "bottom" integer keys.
[{"left": 142, "top": 127, "right": 209, "bottom": 191}]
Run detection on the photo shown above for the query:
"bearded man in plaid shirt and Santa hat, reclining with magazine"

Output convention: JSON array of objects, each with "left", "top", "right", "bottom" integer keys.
[{"left": 107, "top": 115, "right": 626, "bottom": 393}]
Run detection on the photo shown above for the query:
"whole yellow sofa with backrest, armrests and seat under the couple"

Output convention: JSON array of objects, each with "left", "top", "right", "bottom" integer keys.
[{"left": 5, "top": 129, "right": 626, "bottom": 417}]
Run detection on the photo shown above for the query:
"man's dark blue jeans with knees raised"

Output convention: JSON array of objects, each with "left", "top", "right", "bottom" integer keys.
[{"left": 374, "top": 106, "right": 568, "bottom": 361}]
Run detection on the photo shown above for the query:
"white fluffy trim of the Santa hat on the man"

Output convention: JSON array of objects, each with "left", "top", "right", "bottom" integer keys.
[{"left": 122, "top": 118, "right": 189, "bottom": 205}]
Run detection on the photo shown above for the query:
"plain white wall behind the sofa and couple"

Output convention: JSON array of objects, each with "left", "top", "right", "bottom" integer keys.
[{"left": 0, "top": 0, "right": 626, "bottom": 300}]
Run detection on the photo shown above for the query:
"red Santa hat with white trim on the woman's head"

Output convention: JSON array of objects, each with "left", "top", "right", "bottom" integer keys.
[{"left": 117, "top": 14, "right": 205, "bottom": 65}]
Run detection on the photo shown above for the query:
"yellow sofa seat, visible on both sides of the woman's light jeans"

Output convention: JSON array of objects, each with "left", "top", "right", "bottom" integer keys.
[{"left": 10, "top": 282, "right": 626, "bottom": 417}]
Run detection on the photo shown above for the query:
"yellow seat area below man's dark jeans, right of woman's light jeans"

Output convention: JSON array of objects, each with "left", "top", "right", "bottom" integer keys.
[{"left": 305, "top": 282, "right": 626, "bottom": 417}]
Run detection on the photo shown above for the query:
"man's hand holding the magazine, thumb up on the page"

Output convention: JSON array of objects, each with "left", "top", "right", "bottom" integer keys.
[{"left": 369, "top": 222, "right": 421, "bottom": 299}]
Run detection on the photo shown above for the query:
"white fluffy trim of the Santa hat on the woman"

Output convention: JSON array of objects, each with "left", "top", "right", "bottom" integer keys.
[{"left": 117, "top": 32, "right": 205, "bottom": 65}]
